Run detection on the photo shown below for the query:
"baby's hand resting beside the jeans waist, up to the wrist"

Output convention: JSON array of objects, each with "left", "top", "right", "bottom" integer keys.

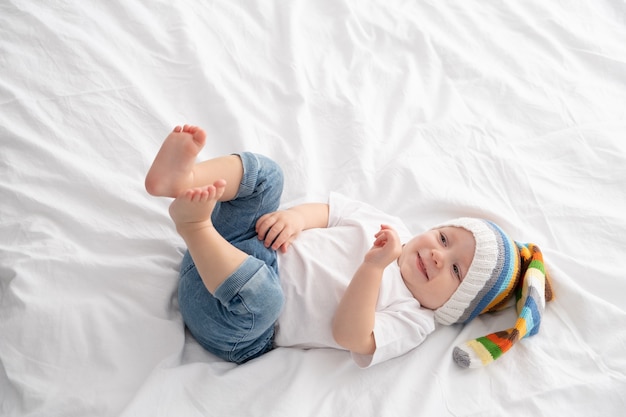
[{"left": 256, "top": 210, "right": 304, "bottom": 253}]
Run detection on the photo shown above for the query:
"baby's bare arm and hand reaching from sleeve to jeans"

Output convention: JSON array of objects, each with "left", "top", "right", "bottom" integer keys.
[{"left": 256, "top": 203, "right": 328, "bottom": 252}]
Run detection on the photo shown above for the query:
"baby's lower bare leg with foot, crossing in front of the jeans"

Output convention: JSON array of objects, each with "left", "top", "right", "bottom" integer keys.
[{"left": 170, "top": 180, "right": 248, "bottom": 294}]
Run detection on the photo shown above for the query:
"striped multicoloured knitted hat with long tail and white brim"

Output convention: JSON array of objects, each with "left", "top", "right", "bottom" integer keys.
[{"left": 435, "top": 217, "right": 552, "bottom": 368}]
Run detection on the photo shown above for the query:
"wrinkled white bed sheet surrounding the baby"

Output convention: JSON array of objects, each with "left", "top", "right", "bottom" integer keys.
[{"left": 0, "top": 0, "right": 626, "bottom": 417}]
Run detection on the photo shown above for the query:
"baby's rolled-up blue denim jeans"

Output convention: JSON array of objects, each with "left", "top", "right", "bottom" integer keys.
[{"left": 178, "top": 153, "right": 284, "bottom": 363}]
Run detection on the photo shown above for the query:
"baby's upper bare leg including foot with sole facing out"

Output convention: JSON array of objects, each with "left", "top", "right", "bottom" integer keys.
[{"left": 145, "top": 125, "right": 243, "bottom": 201}]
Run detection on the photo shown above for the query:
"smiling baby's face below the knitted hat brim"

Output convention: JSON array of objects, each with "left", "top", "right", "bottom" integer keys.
[{"left": 398, "top": 226, "right": 476, "bottom": 310}]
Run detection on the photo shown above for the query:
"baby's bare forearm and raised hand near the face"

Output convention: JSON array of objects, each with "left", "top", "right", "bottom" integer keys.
[{"left": 333, "top": 225, "right": 402, "bottom": 355}]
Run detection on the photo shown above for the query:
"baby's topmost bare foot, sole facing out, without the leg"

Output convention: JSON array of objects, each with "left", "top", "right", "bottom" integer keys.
[{"left": 145, "top": 125, "right": 206, "bottom": 197}]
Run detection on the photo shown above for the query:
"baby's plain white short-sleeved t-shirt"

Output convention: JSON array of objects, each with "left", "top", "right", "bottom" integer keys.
[{"left": 275, "top": 193, "right": 435, "bottom": 368}]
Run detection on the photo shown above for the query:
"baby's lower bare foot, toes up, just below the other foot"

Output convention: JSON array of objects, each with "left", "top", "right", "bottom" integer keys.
[{"left": 170, "top": 180, "right": 226, "bottom": 229}]
